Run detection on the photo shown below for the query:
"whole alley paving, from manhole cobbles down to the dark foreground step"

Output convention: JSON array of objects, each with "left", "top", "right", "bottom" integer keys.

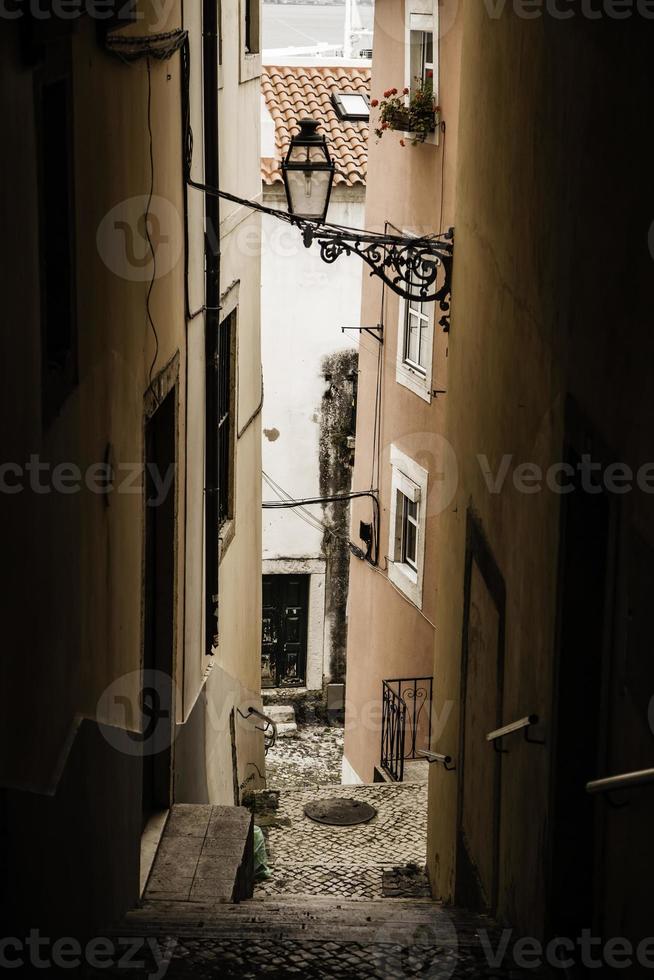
[{"left": 87, "top": 784, "right": 537, "bottom": 980}]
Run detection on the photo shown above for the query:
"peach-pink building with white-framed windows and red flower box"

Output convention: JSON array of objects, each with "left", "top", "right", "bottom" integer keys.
[{"left": 343, "top": 0, "right": 460, "bottom": 782}]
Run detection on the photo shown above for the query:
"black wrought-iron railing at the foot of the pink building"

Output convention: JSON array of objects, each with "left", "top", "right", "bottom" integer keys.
[{"left": 381, "top": 677, "right": 432, "bottom": 783}]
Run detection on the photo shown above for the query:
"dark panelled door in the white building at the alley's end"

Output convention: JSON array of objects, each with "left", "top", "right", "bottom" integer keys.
[{"left": 261, "top": 575, "right": 310, "bottom": 688}]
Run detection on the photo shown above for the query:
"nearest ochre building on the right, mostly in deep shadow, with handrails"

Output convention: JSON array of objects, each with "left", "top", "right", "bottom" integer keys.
[{"left": 429, "top": 3, "right": 654, "bottom": 948}]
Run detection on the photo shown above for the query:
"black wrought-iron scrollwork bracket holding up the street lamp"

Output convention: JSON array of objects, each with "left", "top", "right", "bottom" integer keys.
[{"left": 297, "top": 222, "right": 454, "bottom": 333}]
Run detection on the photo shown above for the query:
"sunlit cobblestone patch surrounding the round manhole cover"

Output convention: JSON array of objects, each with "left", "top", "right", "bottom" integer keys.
[{"left": 255, "top": 783, "right": 427, "bottom": 898}]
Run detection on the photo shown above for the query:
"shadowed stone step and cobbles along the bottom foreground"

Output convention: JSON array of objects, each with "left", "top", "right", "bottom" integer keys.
[{"left": 89, "top": 898, "right": 539, "bottom": 980}]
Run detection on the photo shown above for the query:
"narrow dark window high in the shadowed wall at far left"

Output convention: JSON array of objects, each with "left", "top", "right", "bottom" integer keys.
[{"left": 37, "top": 69, "right": 77, "bottom": 423}]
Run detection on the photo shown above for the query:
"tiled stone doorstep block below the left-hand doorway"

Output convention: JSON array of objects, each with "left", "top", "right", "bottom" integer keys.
[{"left": 143, "top": 804, "right": 254, "bottom": 903}]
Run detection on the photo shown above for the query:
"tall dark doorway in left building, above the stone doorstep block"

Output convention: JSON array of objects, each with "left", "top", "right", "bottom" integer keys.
[{"left": 141, "top": 387, "right": 177, "bottom": 827}]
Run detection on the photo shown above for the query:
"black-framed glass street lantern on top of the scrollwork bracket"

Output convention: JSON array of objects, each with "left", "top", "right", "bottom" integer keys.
[{"left": 282, "top": 119, "right": 336, "bottom": 224}]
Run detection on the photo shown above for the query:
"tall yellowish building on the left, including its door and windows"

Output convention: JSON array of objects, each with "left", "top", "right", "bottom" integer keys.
[{"left": 0, "top": 0, "right": 264, "bottom": 934}]
